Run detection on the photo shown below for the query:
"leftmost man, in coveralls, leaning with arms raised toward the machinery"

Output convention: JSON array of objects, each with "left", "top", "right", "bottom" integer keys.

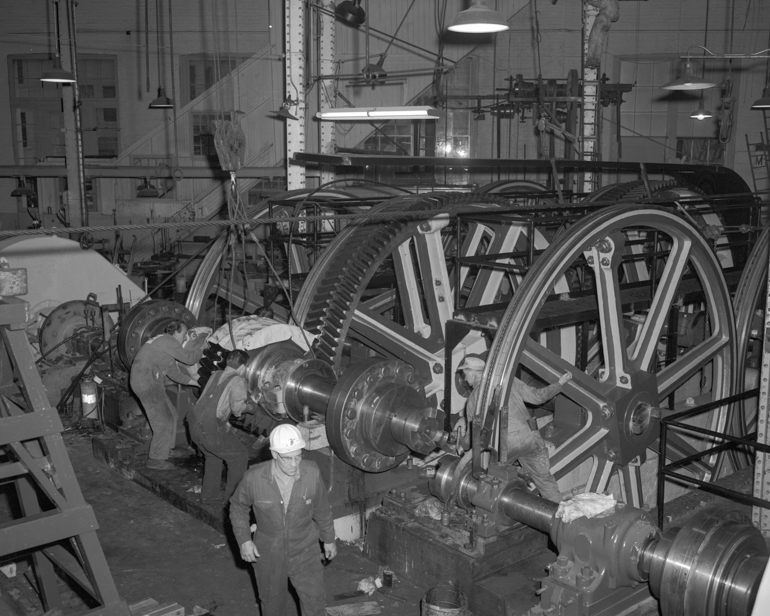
[{"left": 131, "top": 321, "right": 202, "bottom": 471}]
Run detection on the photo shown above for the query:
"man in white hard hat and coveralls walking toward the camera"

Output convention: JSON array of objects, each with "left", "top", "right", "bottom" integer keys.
[{"left": 230, "top": 424, "right": 337, "bottom": 616}]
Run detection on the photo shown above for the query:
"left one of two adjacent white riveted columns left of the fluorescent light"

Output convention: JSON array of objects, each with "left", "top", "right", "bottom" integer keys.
[{"left": 284, "top": 0, "right": 307, "bottom": 190}]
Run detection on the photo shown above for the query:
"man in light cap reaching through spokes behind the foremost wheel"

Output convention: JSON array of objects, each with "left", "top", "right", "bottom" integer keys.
[{"left": 454, "top": 357, "right": 572, "bottom": 503}]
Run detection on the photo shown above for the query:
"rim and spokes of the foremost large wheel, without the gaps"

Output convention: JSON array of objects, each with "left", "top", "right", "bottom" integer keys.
[{"left": 479, "top": 206, "right": 737, "bottom": 506}]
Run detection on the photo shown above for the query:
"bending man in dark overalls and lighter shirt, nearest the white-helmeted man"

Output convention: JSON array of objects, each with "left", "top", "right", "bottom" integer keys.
[{"left": 188, "top": 350, "right": 256, "bottom": 503}]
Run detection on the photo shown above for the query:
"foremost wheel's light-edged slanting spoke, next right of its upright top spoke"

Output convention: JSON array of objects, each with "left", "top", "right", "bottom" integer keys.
[{"left": 631, "top": 238, "right": 692, "bottom": 371}]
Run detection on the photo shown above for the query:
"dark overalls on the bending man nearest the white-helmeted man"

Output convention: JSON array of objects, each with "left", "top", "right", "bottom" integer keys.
[{"left": 188, "top": 368, "right": 249, "bottom": 500}]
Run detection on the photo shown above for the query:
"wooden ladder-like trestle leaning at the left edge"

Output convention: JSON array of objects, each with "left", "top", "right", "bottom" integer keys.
[{"left": 0, "top": 297, "right": 129, "bottom": 616}]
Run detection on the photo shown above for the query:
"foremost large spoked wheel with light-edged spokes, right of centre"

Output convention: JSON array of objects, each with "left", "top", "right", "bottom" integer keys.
[{"left": 479, "top": 205, "right": 737, "bottom": 506}]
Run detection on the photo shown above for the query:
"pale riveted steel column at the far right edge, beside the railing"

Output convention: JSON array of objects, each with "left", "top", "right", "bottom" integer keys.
[{"left": 751, "top": 244, "right": 770, "bottom": 537}]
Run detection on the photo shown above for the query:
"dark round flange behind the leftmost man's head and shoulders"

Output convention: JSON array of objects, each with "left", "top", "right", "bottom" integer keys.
[{"left": 118, "top": 299, "right": 196, "bottom": 368}]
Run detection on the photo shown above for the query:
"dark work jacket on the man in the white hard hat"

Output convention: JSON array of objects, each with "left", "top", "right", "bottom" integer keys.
[{"left": 230, "top": 460, "right": 334, "bottom": 558}]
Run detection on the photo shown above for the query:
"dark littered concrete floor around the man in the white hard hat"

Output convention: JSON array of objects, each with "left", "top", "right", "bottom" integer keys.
[{"left": 0, "top": 431, "right": 751, "bottom": 616}]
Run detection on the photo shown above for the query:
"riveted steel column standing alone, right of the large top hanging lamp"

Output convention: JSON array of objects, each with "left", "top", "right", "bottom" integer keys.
[{"left": 580, "top": 2, "right": 601, "bottom": 193}]
